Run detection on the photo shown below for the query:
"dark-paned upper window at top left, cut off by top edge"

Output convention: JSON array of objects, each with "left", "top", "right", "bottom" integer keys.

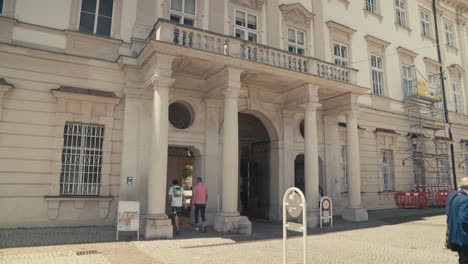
[{"left": 79, "top": 0, "right": 114, "bottom": 36}]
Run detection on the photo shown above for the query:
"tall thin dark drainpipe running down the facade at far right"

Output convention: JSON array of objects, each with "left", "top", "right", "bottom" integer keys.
[{"left": 432, "top": 0, "right": 458, "bottom": 189}]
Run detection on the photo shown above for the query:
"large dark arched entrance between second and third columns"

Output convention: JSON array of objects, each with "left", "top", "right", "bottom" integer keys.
[{"left": 239, "top": 113, "right": 271, "bottom": 219}]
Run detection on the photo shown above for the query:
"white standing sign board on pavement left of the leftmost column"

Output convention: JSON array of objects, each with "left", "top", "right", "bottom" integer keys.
[{"left": 116, "top": 201, "right": 140, "bottom": 240}]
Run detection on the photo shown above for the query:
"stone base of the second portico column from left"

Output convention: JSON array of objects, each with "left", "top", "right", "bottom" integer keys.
[{"left": 214, "top": 215, "right": 252, "bottom": 236}]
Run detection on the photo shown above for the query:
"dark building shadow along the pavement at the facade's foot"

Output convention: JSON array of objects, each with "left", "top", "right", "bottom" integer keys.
[{"left": 0, "top": 208, "right": 445, "bottom": 249}]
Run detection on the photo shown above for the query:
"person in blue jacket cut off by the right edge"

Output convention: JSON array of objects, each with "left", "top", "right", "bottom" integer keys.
[{"left": 445, "top": 177, "right": 468, "bottom": 264}]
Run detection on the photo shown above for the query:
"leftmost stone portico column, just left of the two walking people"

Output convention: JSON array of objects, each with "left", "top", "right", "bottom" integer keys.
[{"left": 145, "top": 77, "right": 174, "bottom": 239}]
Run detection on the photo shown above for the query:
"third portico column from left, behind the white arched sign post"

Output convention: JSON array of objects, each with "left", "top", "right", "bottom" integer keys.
[{"left": 304, "top": 102, "right": 319, "bottom": 227}]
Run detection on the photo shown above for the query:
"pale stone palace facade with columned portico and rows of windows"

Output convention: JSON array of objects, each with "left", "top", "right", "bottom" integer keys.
[{"left": 0, "top": 0, "right": 468, "bottom": 237}]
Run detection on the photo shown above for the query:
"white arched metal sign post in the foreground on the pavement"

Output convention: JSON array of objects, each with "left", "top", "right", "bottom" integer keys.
[{"left": 283, "top": 187, "right": 307, "bottom": 264}]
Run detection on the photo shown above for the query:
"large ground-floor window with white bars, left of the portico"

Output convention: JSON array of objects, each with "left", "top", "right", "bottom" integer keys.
[{"left": 60, "top": 123, "right": 104, "bottom": 195}]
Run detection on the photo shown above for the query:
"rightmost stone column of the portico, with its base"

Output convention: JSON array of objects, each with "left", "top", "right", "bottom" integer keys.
[{"left": 343, "top": 110, "right": 368, "bottom": 222}]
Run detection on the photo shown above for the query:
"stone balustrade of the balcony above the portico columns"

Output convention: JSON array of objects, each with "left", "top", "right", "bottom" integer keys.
[{"left": 150, "top": 19, "right": 357, "bottom": 84}]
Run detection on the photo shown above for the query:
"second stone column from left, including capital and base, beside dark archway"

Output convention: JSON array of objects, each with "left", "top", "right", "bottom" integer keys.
[{"left": 214, "top": 68, "right": 252, "bottom": 234}]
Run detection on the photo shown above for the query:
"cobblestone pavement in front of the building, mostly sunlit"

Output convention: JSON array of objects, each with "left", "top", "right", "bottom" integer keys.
[{"left": 0, "top": 210, "right": 457, "bottom": 264}]
